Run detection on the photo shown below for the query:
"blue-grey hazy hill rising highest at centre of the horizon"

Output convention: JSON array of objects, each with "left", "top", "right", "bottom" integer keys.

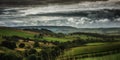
[{"left": 15, "top": 26, "right": 79, "bottom": 33}]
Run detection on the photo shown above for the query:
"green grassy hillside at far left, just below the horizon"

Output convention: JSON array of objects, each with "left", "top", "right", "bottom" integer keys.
[{"left": 0, "top": 28, "right": 36, "bottom": 38}]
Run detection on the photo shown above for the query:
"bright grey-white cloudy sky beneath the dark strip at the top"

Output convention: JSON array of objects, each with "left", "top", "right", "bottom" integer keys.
[{"left": 0, "top": 0, "right": 120, "bottom": 28}]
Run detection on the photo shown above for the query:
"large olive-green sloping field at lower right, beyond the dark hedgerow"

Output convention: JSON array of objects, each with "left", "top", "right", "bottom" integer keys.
[{"left": 63, "top": 42, "right": 120, "bottom": 56}]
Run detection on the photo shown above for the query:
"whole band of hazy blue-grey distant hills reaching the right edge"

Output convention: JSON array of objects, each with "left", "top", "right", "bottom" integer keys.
[{"left": 12, "top": 26, "right": 120, "bottom": 34}]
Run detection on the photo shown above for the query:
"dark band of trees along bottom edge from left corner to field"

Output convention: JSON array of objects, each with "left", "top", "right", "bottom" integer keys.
[{"left": 0, "top": 47, "right": 62, "bottom": 60}]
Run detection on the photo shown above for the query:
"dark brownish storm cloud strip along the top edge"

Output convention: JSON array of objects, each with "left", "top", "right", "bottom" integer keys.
[{"left": 0, "top": 0, "right": 107, "bottom": 5}]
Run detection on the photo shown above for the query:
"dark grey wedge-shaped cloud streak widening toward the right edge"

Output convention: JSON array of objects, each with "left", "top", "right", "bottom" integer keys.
[{"left": 27, "top": 9, "right": 120, "bottom": 20}]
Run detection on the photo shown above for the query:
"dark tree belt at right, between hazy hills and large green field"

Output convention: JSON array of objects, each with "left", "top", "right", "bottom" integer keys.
[{"left": 69, "top": 32, "right": 120, "bottom": 43}]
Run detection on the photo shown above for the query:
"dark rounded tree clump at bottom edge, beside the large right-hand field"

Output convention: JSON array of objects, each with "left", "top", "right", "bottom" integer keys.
[{"left": 38, "top": 47, "right": 62, "bottom": 60}]
